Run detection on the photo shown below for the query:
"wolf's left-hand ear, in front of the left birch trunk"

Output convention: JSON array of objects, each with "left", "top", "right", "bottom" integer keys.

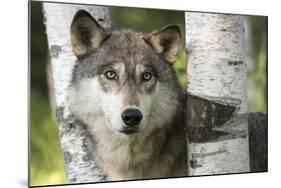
[{"left": 70, "top": 10, "right": 107, "bottom": 58}]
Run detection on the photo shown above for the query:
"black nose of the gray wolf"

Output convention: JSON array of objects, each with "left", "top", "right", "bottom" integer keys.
[{"left": 121, "top": 108, "right": 142, "bottom": 127}]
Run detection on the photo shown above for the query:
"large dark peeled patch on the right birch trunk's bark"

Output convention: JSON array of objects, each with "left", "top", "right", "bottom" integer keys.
[{"left": 186, "top": 94, "right": 238, "bottom": 142}]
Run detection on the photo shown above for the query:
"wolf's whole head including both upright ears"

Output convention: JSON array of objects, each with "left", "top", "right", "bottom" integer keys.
[{"left": 69, "top": 10, "right": 181, "bottom": 134}]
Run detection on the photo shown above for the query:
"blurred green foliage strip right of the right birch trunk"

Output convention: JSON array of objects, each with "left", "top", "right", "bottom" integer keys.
[{"left": 247, "top": 16, "right": 267, "bottom": 113}]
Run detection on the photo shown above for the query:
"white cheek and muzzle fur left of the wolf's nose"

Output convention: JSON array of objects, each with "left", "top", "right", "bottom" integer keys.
[{"left": 68, "top": 77, "right": 122, "bottom": 130}]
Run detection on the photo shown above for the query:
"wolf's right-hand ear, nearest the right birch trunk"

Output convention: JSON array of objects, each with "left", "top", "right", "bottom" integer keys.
[{"left": 145, "top": 25, "right": 181, "bottom": 64}]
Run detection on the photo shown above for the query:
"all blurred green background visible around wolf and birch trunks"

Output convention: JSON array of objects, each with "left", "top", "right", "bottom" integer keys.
[{"left": 30, "top": 2, "right": 267, "bottom": 186}]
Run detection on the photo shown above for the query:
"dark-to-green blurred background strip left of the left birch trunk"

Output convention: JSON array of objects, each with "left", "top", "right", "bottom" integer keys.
[{"left": 30, "top": 2, "right": 66, "bottom": 185}]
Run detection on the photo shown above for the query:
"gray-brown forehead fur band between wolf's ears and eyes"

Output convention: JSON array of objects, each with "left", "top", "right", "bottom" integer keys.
[{"left": 72, "top": 30, "right": 176, "bottom": 83}]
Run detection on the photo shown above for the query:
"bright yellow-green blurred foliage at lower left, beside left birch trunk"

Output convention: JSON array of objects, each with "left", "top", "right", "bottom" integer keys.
[{"left": 30, "top": 90, "right": 66, "bottom": 185}]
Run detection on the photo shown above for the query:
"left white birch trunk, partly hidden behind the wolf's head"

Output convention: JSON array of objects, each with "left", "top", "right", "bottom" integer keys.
[{"left": 43, "top": 2, "right": 111, "bottom": 183}]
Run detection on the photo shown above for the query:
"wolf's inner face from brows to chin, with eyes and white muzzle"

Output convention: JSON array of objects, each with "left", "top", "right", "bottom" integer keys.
[{"left": 95, "top": 62, "right": 157, "bottom": 133}]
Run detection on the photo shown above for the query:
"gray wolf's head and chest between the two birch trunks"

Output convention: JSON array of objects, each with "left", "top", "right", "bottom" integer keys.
[{"left": 68, "top": 10, "right": 187, "bottom": 181}]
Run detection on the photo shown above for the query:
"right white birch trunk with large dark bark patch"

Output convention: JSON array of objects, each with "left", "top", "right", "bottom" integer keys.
[{"left": 185, "top": 12, "right": 250, "bottom": 176}]
